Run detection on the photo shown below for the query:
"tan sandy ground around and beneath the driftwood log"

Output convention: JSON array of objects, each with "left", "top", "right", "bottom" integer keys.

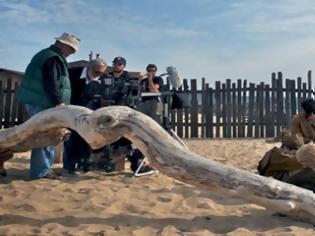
[{"left": 0, "top": 139, "right": 315, "bottom": 236}]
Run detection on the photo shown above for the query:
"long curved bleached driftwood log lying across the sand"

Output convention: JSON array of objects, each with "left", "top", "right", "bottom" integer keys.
[{"left": 0, "top": 106, "right": 315, "bottom": 224}]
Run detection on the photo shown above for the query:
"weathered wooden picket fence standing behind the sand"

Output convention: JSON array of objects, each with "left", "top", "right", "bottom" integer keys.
[{"left": 0, "top": 71, "right": 313, "bottom": 138}]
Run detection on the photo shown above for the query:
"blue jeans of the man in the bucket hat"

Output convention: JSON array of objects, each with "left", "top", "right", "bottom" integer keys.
[{"left": 25, "top": 104, "right": 55, "bottom": 179}]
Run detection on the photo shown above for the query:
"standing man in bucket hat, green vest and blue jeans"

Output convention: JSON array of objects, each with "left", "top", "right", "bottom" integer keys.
[{"left": 17, "top": 33, "right": 80, "bottom": 179}]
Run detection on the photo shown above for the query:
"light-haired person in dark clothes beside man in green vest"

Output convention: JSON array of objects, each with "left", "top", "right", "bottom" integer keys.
[{"left": 63, "top": 58, "right": 107, "bottom": 174}]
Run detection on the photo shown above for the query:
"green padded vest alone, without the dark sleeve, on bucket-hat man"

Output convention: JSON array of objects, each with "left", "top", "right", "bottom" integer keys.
[{"left": 17, "top": 45, "right": 71, "bottom": 108}]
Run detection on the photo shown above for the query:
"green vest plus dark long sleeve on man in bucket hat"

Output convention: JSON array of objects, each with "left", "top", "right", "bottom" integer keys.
[{"left": 17, "top": 45, "right": 71, "bottom": 108}]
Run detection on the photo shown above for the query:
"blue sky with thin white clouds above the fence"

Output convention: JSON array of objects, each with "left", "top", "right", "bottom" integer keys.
[{"left": 0, "top": 0, "right": 315, "bottom": 85}]
